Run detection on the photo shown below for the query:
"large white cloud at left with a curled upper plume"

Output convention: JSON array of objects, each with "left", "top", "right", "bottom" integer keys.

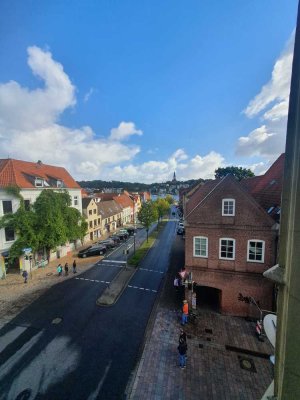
[{"left": 0, "top": 47, "right": 142, "bottom": 179}]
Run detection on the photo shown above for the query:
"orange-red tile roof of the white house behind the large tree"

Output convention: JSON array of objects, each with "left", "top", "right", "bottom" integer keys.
[{"left": 0, "top": 159, "right": 80, "bottom": 189}]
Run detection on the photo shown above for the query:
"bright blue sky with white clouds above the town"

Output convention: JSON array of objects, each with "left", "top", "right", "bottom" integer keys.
[{"left": 0, "top": 0, "right": 297, "bottom": 183}]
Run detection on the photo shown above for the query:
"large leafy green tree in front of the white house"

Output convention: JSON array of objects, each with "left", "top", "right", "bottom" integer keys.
[{"left": 0, "top": 188, "right": 87, "bottom": 262}]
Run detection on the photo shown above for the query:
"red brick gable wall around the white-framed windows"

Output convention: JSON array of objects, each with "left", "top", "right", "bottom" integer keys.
[{"left": 185, "top": 179, "right": 276, "bottom": 316}]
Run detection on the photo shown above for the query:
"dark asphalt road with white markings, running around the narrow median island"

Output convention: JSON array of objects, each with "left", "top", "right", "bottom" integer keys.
[{"left": 0, "top": 221, "right": 176, "bottom": 400}]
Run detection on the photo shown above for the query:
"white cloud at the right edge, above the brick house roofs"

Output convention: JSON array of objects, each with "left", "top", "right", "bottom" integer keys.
[{"left": 236, "top": 33, "right": 294, "bottom": 160}]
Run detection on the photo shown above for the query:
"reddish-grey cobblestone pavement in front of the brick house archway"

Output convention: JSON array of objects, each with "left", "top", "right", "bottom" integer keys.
[{"left": 129, "top": 306, "right": 273, "bottom": 400}]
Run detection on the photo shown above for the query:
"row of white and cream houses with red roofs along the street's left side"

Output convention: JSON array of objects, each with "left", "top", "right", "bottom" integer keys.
[{"left": 0, "top": 159, "right": 150, "bottom": 278}]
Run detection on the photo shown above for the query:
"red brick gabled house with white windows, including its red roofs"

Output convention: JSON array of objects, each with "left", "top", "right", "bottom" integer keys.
[{"left": 180, "top": 154, "right": 284, "bottom": 316}]
